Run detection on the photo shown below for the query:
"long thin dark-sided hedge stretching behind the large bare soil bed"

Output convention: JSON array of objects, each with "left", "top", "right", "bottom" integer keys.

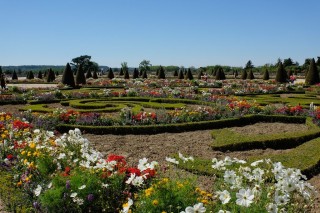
[{"left": 56, "top": 115, "right": 306, "bottom": 135}]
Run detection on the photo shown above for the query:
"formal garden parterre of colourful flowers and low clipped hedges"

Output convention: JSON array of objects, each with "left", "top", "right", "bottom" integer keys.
[{"left": 0, "top": 62, "right": 320, "bottom": 213}]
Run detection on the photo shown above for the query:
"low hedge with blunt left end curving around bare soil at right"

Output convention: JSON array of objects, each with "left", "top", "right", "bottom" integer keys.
[{"left": 211, "top": 118, "right": 320, "bottom": 152}]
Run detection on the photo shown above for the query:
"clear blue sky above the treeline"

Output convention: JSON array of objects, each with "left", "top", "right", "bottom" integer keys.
[{"left": 0, "top": 0, "right": 320, "bottom": 67}]
